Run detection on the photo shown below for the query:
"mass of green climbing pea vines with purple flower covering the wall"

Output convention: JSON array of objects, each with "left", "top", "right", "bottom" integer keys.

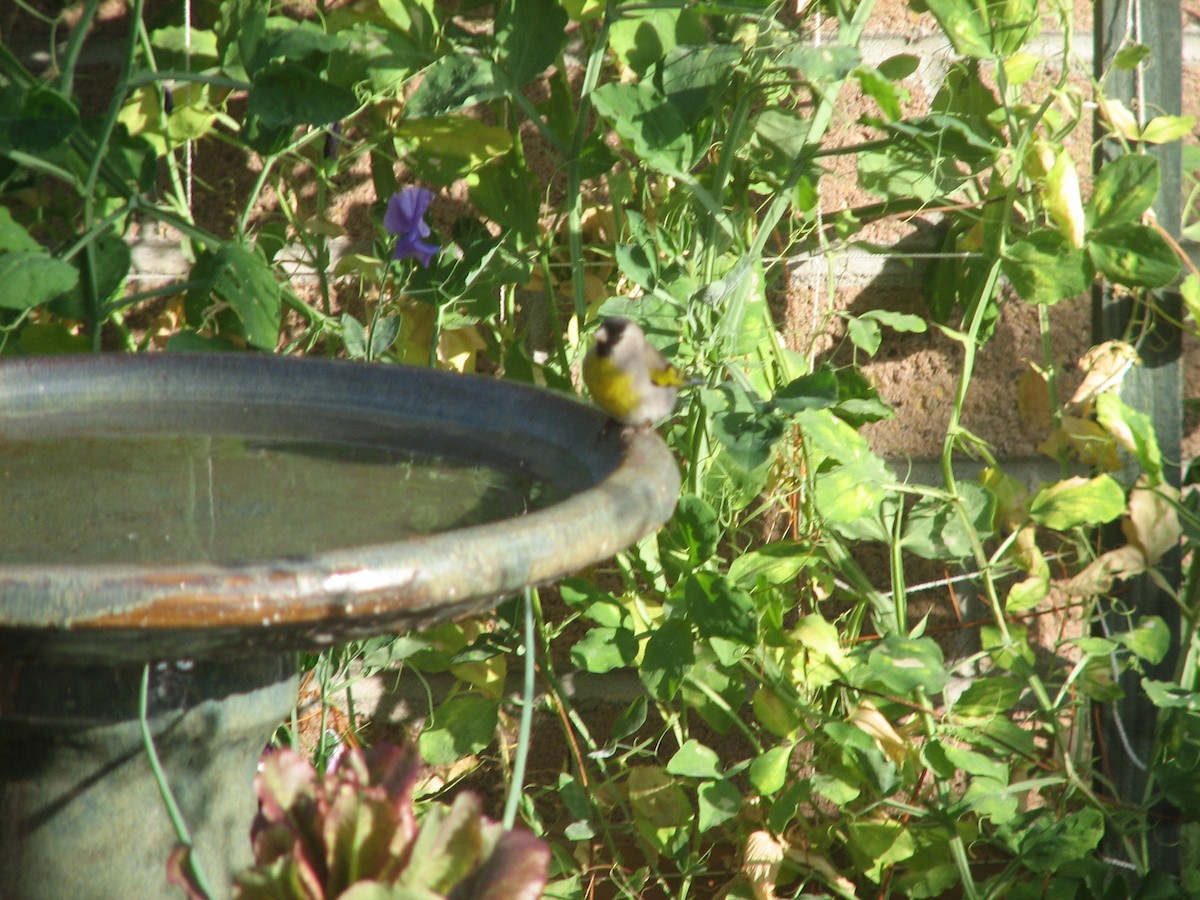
[{"left": 0, "top": 0, "right": 1200, "bottom": 898}]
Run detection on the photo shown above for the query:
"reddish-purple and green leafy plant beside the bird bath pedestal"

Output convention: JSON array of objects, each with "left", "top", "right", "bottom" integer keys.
[{"left": 172, "top": 745, "right": 550, "bottom": 900}]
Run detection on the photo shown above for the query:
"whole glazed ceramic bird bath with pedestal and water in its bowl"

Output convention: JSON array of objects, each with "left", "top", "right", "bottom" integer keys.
[{"left": 0, "top": 354, "right": 678, "bottom": 900}]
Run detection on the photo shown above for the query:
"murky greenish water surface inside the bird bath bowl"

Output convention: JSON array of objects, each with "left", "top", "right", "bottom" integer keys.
[{"left": 0, "top": 436, "right": 559, "bottom": 565}]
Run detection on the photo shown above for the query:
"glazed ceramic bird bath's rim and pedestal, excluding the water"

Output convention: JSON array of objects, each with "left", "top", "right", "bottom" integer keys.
[{"left": 0, "top": 353, "right": 679, "bottom": 900}]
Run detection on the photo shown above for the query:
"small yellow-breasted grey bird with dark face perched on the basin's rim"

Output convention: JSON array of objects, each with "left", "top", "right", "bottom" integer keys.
[{"left": 583, "top": 317, "right": 689, "bottom": 428}]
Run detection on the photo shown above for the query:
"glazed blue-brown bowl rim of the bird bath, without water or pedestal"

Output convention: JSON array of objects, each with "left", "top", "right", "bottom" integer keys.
[{"left": 0, "top": 353, "right": 679, "bottom": 664}]
